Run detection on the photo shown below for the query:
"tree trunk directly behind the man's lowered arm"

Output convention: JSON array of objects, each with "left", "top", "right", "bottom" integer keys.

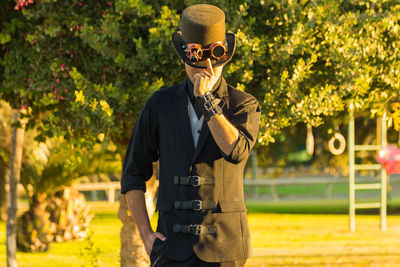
[{"left": 118, "top": 164, "right": 158, "bottom": 267}]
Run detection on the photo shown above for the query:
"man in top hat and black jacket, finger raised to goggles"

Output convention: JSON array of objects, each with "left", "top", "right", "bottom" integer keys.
[{"left": 121, "top": 4, "right": 260, "bottom": 266}]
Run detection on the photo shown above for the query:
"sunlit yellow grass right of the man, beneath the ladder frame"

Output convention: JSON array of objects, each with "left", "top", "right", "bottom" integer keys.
[{"left": 247, "top": 214, "right": 400, "bottom": 266}]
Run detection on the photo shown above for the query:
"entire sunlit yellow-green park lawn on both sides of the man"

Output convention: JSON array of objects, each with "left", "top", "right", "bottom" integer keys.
[{"left": 0, "top": 200, "right": 400, "bottom": 267}]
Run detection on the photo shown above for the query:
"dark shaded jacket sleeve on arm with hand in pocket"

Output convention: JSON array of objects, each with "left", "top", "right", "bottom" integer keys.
[{"left": 121, "top": 95, "right": 159, "bottom": 194}]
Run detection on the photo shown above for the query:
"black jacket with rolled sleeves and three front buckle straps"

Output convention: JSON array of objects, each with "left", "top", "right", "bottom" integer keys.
[{"left": 121, "top": 79, "right": 261, "bottom": 262}]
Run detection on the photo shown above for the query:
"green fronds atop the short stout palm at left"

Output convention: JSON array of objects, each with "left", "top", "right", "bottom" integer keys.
[{"left": 20, "top": 137, "right": 121, "bottom": 196}]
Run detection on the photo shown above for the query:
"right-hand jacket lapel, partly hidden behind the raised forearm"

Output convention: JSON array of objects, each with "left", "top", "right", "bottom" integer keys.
[{"left": 189, "top": 77, "right": 228, "bottom": 164}]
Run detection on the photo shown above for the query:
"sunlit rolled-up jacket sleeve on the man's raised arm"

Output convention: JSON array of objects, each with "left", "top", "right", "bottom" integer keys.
[{"left": 225, "top": 97, "right": 261, "bottom": 164}]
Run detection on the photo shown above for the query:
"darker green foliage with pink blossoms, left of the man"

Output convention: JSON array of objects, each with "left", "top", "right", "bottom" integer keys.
[{"left": 2, "top": 0, "right": 184, "bottom": 150}]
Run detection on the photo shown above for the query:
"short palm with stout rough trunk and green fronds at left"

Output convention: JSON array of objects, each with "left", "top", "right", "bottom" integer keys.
[{"left": 17, "top": 134, "right": 121, "bottom": 252}]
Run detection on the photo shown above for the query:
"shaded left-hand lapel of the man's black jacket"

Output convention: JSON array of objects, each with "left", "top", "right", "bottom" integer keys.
[{"left": 173, "top": 80, "right": 195, "bottom": 158}]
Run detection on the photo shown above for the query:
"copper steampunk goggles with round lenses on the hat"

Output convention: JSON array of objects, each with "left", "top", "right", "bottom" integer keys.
[{"left": 183, "top": 41, "right": 228, "bottom": 63}]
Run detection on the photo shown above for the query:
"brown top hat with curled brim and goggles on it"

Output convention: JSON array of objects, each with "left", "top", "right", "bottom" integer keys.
[{"left": 172, "top": 4, "right": 236, "bottom": 68}]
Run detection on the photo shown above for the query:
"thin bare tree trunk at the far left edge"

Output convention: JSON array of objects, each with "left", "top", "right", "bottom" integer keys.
[{"left": 7, "top": 111, "right": 25, "bottom": 267}]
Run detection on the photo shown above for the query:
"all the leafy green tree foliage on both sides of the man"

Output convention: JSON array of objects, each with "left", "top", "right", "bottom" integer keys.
[{"left": 0, "top": 0, "right": 400, "bottom": 158}]
